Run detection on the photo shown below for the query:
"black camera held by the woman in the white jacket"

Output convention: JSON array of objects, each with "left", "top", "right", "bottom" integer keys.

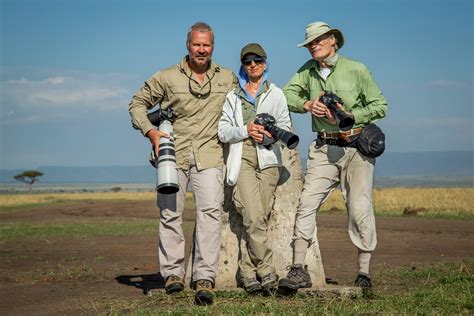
[{"left": 254, "top": 113, "right": 300, "bottom": 149}]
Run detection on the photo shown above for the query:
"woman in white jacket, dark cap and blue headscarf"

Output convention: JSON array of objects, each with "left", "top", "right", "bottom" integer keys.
[{"left": 218, "top": 43, "right": 291, "bottom": 293}]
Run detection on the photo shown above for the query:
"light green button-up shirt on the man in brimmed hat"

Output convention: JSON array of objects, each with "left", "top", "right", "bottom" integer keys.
[{"left": 284, "top": 56, "right": 387, "bottom": 132}]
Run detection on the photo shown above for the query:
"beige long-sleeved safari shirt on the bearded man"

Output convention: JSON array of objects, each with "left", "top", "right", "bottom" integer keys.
[{"left": 129, "top": 56, "right": 235, "bottom": 170}]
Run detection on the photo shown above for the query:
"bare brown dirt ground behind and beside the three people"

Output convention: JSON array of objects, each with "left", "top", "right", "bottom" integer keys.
[{"left": 0, "top": 201, "right": 474, "bottom": 315}]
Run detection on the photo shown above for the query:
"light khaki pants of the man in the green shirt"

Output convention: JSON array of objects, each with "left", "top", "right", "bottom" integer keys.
[{"left": 293, "top": 141, "right": 377, "bottom": 252}]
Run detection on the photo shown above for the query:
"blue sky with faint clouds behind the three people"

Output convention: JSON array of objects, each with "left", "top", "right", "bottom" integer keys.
[{"left": 0, "top": 0, "right": 474, "bottom": 169}]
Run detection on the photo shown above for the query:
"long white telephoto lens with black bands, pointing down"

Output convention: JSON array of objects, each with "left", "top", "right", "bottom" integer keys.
[{"left": 156, "top": 119, "right": 179, "bottom": 194}]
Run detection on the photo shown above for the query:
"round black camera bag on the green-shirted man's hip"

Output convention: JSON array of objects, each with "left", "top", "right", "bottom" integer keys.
[{"left": 355, "top": 124, "right": 385, "bottom": 158}]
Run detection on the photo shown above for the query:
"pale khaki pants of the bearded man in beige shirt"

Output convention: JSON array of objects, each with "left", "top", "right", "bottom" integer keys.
[{"left": 157, "top": 154, "right": 224, "bottom": 284}]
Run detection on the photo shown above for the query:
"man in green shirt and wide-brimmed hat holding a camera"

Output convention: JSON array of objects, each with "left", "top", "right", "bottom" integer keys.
[{"left": 278, "top": 22, "right": 387, "bottom": 290}]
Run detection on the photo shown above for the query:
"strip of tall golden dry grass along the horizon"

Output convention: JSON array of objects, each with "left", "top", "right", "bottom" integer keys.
[{"left": 0, "top": 188, "right": 474, "bottom": 217}]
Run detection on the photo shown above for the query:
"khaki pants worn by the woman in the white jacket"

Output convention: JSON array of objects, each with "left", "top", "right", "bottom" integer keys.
[{"left": 234, "top": 140, "right": 279, "bottom": 278}]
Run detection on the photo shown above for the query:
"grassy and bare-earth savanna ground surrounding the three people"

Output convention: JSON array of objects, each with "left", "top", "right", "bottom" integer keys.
[{"left": 0, "top": 188, "right": 474, "bottom": 315}]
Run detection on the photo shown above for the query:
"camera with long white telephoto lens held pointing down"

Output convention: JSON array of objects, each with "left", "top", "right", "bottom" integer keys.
[{"left": 147, "top": 108, "right": 179, "bottom": 194}]
